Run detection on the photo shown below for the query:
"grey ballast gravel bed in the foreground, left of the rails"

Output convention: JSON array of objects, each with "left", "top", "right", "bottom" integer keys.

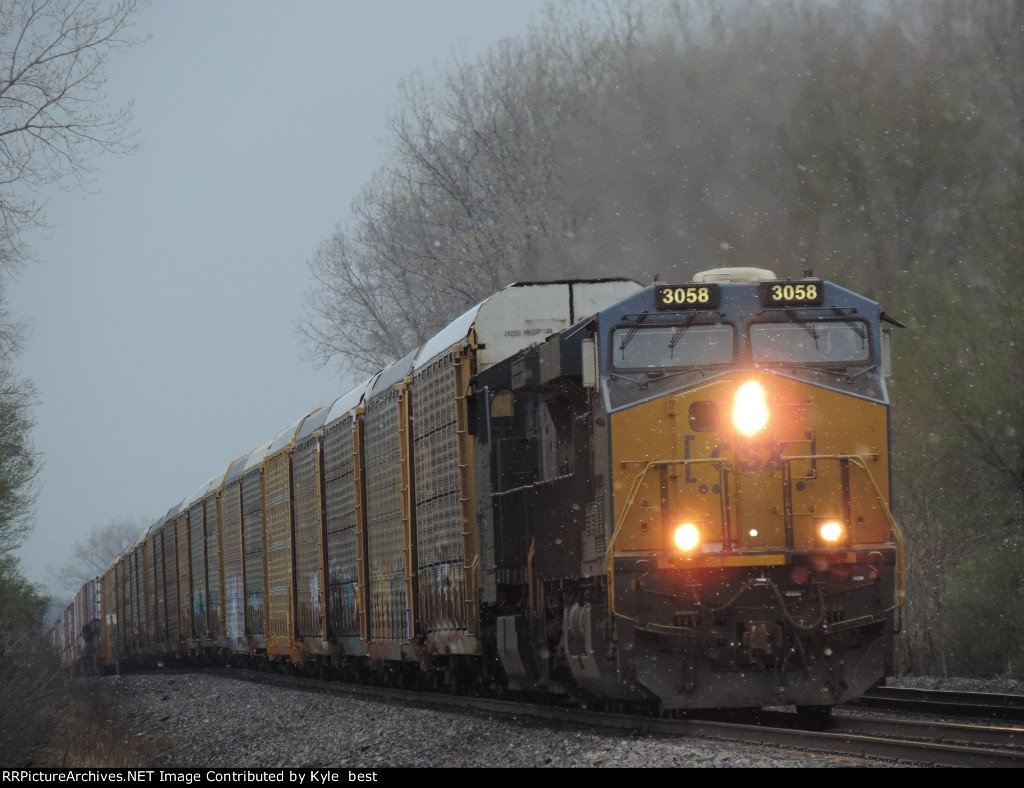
[{"left": 101, "top": 673, "right": 882, "bottom": 769}]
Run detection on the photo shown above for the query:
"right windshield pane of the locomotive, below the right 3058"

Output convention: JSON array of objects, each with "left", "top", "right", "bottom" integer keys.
[{"left": 751, "top": 320, "right": 870, "bottom": 364}]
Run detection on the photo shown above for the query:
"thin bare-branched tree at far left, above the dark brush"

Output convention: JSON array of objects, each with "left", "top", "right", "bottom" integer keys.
[{"left": 0, "top": 0, "right": 145, "bottom": 555}]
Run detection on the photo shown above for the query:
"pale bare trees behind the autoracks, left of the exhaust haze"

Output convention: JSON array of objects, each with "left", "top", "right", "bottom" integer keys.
[{"left": 299, "top": 0, "right": 642, "bottom": 373}]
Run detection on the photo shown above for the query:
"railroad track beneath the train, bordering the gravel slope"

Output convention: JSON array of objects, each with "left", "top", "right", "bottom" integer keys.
[{"left": 203, "top": 669, "right": 1024, "bottom": 768}]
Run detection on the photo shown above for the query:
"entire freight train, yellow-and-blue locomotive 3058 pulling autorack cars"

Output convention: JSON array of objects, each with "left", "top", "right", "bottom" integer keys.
[{"left": 54, "top": 269, "right": 903, "bottom": 713}]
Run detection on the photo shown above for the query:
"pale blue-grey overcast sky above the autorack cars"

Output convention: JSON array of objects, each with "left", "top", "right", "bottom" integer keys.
[{"left": 11, "top": 0, "right": 544, "bottom": 597}]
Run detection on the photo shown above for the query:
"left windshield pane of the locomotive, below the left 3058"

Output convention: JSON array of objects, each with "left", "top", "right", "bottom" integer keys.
[{"left": 611, "top": 324, "right": 733, "bottom": 369}]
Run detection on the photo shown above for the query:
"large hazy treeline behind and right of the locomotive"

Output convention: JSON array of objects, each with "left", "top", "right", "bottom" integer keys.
[{"left": 303, "top": 0, "right": 1024, "bottom": 676}]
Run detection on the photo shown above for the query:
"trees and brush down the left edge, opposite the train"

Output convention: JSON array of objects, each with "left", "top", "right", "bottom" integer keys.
[{"left": 0, "top": 0, "right": 145, "bottom": 769}]
